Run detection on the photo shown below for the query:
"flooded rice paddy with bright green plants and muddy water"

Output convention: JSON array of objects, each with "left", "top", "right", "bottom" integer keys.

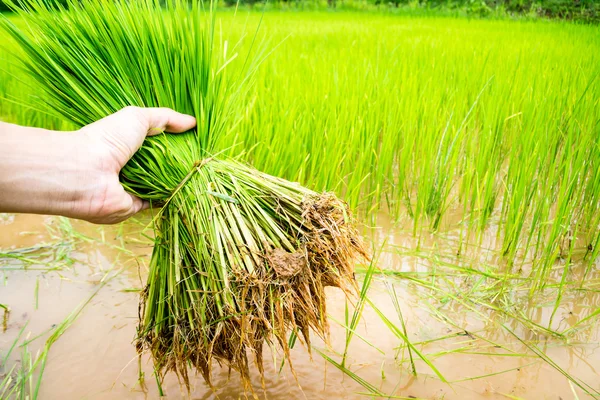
[{"left": 0, "top": 9, "right": 600, "bottom": 399}]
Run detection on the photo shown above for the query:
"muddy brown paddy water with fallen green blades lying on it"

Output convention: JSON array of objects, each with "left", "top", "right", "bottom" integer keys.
[{"left": 0, "top": 214, "right": 600, "bottom": 399}]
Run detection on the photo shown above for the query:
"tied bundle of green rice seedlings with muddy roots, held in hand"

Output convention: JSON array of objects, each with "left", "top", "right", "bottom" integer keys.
[{"left": 3, "top": 0, "right": 366, "bottom": 386}]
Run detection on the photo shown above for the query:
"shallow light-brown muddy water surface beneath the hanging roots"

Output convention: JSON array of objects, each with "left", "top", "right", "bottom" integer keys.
[{"left": 0, "top": 215, "right": 600, "bottom": 399}]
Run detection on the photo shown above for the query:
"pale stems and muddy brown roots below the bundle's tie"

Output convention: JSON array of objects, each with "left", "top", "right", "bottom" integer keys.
[{"left": 136, "top": 160, "right": 368, "bottom": 390}]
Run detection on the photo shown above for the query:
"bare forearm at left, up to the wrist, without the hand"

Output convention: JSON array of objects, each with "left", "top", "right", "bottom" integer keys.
[{"left": 0, "top": 122, "right": 89, "bottom": 219}]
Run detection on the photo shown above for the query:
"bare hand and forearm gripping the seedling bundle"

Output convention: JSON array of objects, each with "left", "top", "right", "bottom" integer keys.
[{"left": 0, "top": 107, "right": 196, "bottom": 224}]
